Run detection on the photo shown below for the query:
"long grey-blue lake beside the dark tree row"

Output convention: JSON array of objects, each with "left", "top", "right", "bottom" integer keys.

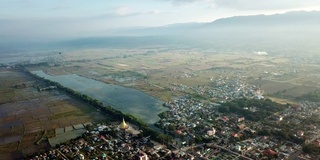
[{"left": 32, "top": 71, "right": 168, "bottom": 124}]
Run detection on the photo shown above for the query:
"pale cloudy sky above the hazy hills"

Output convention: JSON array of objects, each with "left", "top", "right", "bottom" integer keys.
[{"left": 0, "top": 0, "right": 320, "bottom": 40}]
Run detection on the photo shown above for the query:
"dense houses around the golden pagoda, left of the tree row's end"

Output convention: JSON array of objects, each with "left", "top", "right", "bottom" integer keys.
[{"left": 26, "top": 120, "right": 190, "bottom": 160}]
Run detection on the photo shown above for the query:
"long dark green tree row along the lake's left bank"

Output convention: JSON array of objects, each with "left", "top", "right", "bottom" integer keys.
[{"left": 25, "top": 67, "right": 173, "bottom": 144}]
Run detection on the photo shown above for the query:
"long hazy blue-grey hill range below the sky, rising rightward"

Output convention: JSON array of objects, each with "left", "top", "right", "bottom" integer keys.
[{"left": 48, "top": 11, "right": 320, "bottom": 54}]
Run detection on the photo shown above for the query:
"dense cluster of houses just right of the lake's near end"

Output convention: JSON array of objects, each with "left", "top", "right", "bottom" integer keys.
[{"left": 156, "top": 97, "right": 256, "bottom": 145}]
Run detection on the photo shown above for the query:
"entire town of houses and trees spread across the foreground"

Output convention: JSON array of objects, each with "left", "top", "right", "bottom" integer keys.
[{"left": 1, "top": 64, "right": 320, "bottom": 160}]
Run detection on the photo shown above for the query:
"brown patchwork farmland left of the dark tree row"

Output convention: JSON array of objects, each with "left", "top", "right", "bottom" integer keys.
[{"left": 0, "top": 68, "right": 105, "bottom": 159}]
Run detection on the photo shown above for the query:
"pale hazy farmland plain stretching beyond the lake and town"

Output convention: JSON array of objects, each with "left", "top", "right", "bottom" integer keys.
[{"left": 26, "top": 47, "right": 320, "bottom": 101}]
